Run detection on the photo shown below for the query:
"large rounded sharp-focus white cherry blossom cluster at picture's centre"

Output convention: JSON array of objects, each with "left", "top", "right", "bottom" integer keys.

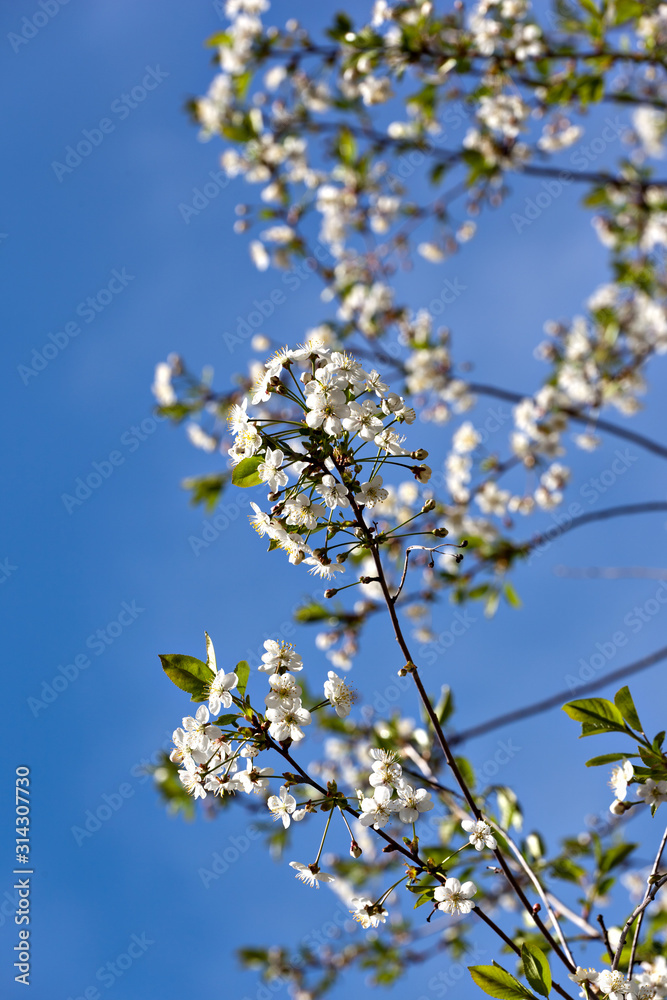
[{"left": 229, "top": 343, "right": 431, "bottom": 579}]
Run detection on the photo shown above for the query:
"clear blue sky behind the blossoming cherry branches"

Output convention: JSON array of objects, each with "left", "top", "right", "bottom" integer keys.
[{"left": 0, "top": 0, "right": 667, "bottom": 1000}]
